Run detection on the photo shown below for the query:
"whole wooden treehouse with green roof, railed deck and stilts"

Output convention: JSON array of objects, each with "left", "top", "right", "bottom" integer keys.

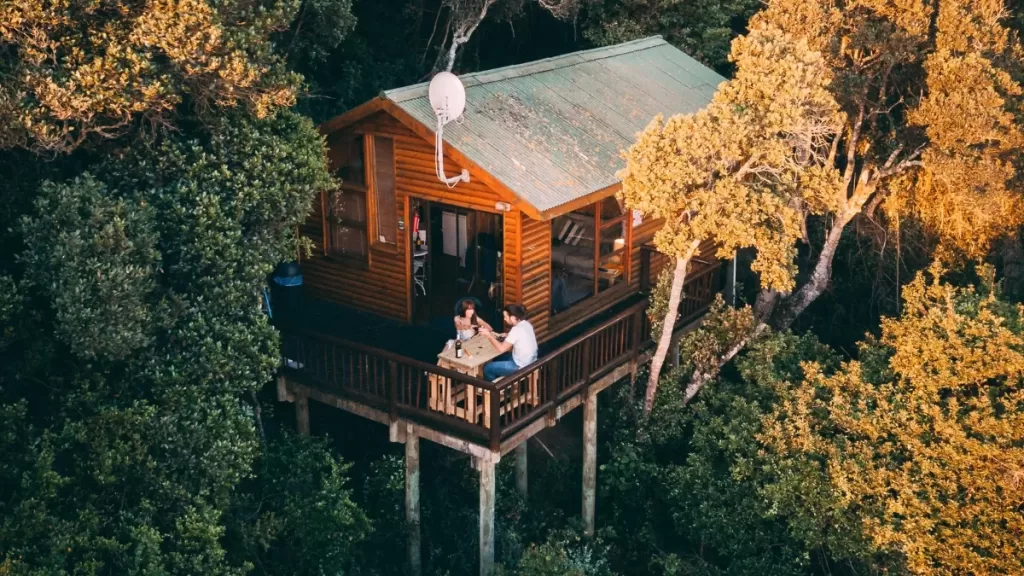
[{"left": 279, "top": 37, "right": 727, "bottom": 573}]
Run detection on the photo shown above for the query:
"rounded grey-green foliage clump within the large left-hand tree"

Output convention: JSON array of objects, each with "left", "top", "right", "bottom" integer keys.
[{"left": 22, "top": 174, "right": 163, "bottom": 360}]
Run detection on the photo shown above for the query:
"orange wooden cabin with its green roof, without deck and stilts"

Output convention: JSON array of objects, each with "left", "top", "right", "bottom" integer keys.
[{"left": 302, "top": 38, "right": 722, "bottom": 340}]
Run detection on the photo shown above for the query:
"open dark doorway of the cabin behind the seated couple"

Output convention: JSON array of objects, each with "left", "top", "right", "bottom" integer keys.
[{"left": 410, "top": 199, "right": 502, "bottom": 332}]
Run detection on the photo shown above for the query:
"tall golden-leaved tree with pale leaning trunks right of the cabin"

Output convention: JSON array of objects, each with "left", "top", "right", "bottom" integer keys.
[{"left": 623, "top": 0, "right": 1024, "bottom": 408}]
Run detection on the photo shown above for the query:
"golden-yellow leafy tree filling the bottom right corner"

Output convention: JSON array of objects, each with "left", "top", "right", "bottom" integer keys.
[{"left": 761, "top": 268, "right": 1024, "bottom": 574}]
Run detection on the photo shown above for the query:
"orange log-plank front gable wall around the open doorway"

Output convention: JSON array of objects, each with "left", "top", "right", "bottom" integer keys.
[{"left": 300, "top": 112, "right": 519, "bottom": 322}]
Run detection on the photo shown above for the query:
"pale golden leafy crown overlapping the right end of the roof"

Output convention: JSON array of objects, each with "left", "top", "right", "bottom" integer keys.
[{"left": 620, "top": 26, "right": 842, "bottom": 290}]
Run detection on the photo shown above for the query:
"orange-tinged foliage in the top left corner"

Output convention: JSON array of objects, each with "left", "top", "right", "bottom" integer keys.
[{"left": 0, "top": 0, "right": 297, "bottom": 152}]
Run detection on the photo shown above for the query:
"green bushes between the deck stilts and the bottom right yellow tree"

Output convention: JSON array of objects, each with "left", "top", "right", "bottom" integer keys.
[{"left": 598, "top": 335, "right": 864, "bottom": 575}]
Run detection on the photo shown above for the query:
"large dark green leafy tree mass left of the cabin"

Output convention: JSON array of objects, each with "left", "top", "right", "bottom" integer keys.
[{"left": 0, "top": 113, "right": 344, "bottom": 574}]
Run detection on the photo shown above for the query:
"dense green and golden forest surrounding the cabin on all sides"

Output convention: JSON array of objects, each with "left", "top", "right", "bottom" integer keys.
[{"left": 0, "top": 0, "right": 1024, "bottom": 576}]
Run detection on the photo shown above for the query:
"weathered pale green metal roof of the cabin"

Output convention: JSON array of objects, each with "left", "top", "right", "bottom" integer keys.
[{"left": 383, "top": 36, "right": 725, "bottom": 212}]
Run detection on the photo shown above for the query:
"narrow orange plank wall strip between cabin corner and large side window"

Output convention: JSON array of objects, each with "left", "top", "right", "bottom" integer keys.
[{"left": 520, "top": 216, "right": 551, "bottom": 340}]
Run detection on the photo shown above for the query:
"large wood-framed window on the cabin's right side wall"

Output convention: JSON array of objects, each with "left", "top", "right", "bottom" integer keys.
[{"left": 551, "top": 198, "right": 629, "bottom": 314}]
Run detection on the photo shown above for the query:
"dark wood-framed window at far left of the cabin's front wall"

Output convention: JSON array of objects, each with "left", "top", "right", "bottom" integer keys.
[{"left": 325, "top": 134, "right": 368, "bottom": 259}]
